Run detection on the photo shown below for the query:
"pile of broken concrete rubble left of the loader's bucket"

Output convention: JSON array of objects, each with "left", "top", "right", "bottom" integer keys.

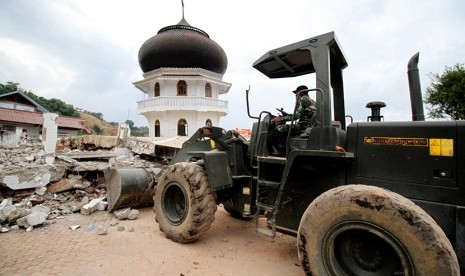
[{"left": 0, "top": 144, "right": 158, "bottom": 234}]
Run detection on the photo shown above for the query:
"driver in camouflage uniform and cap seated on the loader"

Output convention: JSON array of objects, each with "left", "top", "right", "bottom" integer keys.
[{"left": 270, "top": 85, "right": 316, "bottom": 156}]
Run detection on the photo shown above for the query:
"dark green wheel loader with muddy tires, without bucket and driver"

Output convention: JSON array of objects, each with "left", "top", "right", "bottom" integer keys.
[{"left": 150, "top": 32, "right": 465, "bottom": 275}]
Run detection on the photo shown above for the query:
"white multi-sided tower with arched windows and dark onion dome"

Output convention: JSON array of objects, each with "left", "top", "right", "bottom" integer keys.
[{"left": 133, "top": 17, "right": 231, "bottom": 137}]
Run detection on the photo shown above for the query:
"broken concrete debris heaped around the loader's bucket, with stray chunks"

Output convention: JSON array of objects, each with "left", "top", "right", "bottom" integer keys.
[{"left": 0, "top": 136, "right": 169, "bottom": 234}]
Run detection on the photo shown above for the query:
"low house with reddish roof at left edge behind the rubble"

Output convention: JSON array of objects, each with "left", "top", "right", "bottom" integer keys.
[{"left": 0, "top": 91, "right": 90, "bottom": 146}]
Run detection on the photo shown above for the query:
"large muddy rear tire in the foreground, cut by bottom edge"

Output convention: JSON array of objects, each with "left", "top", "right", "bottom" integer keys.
[{"left": 297, "top": 185, "right": 460, "bottom": 276}]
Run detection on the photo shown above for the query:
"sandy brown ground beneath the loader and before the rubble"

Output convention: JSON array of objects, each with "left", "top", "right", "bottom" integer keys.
[{"left": 0, "top": 207, "right": 304, "bottom": 276}]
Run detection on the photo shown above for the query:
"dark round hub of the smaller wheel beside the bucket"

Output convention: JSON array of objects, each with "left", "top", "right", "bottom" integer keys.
[{"left": 162, "top": 182, "right": 188, "bottom": 225}]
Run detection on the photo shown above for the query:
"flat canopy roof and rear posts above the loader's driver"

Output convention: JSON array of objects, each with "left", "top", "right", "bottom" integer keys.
[{"left": 253, "top": 32, "right": 348, "bottom": 130}]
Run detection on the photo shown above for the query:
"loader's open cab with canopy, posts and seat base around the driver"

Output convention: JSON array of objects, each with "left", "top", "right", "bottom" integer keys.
[{"left": 252, "top": 32, "right": 348, "bottom": 155}]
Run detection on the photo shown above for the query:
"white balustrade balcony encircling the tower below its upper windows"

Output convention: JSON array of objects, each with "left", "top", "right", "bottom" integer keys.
[{"left": 137, "top": 96, "right": 228, "bottom": 114}]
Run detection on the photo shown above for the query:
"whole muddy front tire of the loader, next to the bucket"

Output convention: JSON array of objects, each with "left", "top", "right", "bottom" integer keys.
[{"left": 153, "top": 162, "right": 217, "bottom": 243}]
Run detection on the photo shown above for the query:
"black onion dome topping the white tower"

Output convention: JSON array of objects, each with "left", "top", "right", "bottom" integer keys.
[{"left": 139, "top": 18, "right": 228, "bottom": 74}]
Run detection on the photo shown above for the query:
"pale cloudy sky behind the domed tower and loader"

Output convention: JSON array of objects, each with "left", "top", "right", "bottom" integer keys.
[{"left": 0, "top": 0, "right": 465, "bottom": 129}]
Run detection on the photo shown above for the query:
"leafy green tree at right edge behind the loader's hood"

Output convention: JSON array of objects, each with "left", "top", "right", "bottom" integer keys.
[{"left": 425, "top": 64, "right": 465, "bottom": 120}]
